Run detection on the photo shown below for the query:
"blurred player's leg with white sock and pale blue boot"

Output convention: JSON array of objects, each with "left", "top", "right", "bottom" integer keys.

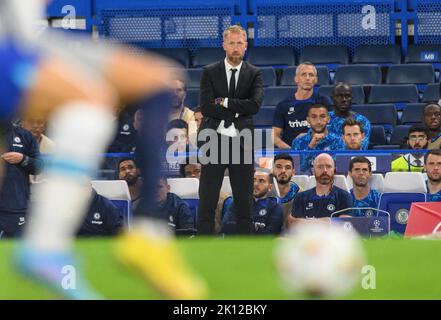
[{"left": 17, "top": 58, "right": 114, "bottom": 299}]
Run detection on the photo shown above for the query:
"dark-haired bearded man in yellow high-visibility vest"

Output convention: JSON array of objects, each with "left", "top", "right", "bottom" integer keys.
[{"left": 391, "top": 124, "right": 429, "bottom": 172}]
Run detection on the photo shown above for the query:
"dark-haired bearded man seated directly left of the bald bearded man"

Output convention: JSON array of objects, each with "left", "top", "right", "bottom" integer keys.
[{"left": 273, "top": 153, "right": 303, "bottom": 228}]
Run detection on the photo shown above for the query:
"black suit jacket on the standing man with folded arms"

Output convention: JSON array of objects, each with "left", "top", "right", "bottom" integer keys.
[{"left": 200, "top": 60, "right": 263, "bottom": 130}]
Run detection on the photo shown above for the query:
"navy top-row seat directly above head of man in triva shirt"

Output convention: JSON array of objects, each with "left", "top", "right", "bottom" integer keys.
[{"left": 299, "top": 46, "right": 349, "bottom": 70}]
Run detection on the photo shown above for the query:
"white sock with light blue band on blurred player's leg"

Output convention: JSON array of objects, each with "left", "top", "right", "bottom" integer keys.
[{"left": 24, "top": 102, "right": 115, "bottom": 251}]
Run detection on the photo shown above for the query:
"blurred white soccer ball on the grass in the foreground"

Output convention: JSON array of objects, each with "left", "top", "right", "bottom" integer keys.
[{"left": 275, "top": 222, "right": 365, "bottom": 297}]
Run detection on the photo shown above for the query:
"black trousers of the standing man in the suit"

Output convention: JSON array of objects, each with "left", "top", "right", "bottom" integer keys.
[{"left": 197, "top": 135, "right": 254, "bottom": 235}]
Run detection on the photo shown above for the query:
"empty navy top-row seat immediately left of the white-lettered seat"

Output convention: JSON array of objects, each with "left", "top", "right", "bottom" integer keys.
[{"left": 352, "top": 45, "right": 401, "bottom": 65}]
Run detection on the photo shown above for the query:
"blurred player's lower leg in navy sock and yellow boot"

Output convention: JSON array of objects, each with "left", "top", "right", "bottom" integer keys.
[{"left": 116, "top": 93, "right": 206, "bottom": 299}]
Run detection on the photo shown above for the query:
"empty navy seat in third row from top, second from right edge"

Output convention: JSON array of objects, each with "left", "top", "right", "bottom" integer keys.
[{"left": 368, "top": 84, "right": 418, "bottom": 110}]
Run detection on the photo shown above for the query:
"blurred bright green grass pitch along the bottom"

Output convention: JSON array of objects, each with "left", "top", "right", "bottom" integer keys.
[{"left": 0, "top": 237, "right": 441, "bottom": 300}]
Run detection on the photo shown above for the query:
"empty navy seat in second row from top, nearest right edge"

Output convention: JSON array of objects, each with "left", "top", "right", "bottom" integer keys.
[{"left": 386, "top": 63, "right": 435, "bottom": 84}]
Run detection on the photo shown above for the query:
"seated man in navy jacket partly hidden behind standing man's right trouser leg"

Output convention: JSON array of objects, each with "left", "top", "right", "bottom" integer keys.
[{"left": 221, "top": 169, "right": 283, "bottom": 235}]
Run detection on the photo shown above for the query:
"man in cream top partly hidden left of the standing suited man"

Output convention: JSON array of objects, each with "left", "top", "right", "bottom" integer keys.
[{"left": 168, "top": 80, "right": 198, "bottom": 145}]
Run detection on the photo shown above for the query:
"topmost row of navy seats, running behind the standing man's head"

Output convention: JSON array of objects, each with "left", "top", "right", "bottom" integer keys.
[{"left": 151, "top": 45, "right": 441, "bottom": 69}]
